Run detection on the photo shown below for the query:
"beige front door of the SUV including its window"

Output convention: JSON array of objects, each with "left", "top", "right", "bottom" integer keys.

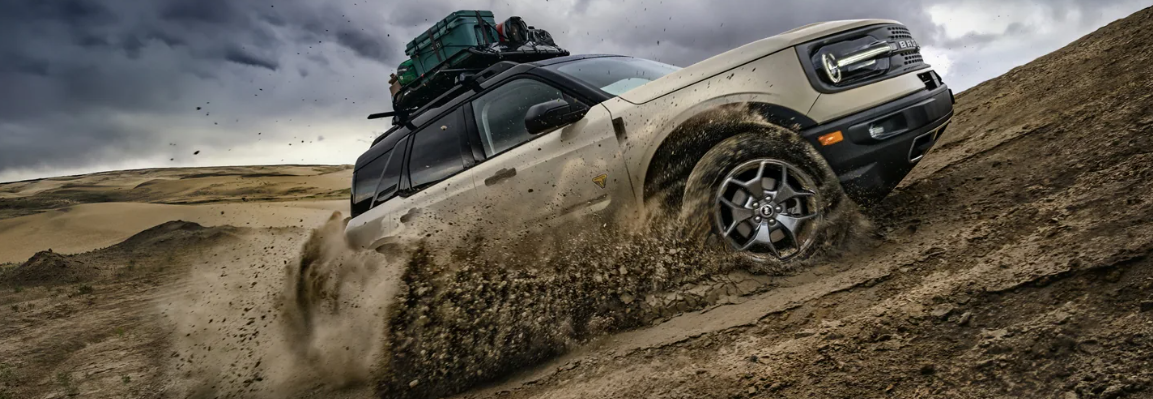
[{"left": 468, "top": 77, "right": 632, "bottom": 230}]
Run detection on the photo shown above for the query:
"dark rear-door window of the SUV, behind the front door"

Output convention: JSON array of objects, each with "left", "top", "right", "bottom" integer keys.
[{"left": 408, "top": 108, "right": 465, "bottom": 188}]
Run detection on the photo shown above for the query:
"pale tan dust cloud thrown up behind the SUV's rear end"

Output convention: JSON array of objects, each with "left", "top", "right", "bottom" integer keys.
[{"left": 160, "top": 213, "right": 400, "bottom": 398}]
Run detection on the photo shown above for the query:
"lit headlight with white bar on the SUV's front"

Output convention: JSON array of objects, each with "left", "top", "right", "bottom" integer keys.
[{"left": 813, "top": 37, "right": 894, "bottom": 85}]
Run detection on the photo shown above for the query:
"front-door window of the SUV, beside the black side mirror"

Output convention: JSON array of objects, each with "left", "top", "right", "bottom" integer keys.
[{"left": 473, "top": 78, "right": 564, "bottom": 157}]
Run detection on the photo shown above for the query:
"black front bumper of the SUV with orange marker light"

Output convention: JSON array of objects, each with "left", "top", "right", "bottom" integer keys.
[{"left": 800, "top": 74, "right": 954, "bottom": 203}]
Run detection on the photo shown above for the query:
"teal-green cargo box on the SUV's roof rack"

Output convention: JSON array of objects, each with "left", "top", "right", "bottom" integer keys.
[{"left": 398, "top": 10, "right": 499, "bottom": 77}]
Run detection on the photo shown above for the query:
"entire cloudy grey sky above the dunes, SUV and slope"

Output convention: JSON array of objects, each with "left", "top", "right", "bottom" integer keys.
[{"left": 0, "top": 0, "right": 1153, "bottom": 181}]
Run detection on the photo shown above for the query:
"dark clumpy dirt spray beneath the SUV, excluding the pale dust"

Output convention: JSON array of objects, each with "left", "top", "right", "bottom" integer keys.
[{"left": 378, "top": 213, "right": 857, "bottom": 398}]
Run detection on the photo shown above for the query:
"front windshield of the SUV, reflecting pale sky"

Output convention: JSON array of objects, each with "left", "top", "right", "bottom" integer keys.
[{"left": 548, "top": 57, "right": 680, "bottom": 96}]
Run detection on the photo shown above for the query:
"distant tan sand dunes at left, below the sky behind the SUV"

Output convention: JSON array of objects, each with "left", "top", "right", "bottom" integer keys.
[{"left": 0, "top": 165, "right": 352, "bottom": 263}]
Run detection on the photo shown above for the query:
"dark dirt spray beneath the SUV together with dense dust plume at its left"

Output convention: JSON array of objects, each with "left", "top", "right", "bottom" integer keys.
[{"left": 280, "top": 216, "right": 867, "bottom": 398}]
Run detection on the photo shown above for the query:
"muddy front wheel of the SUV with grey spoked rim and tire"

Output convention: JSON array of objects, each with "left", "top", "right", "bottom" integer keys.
[{"left": 680, "top": 127, "right": 851, "bottom": 269}]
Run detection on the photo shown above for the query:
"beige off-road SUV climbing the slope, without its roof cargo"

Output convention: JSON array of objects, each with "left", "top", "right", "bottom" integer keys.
[{"left": 346, "top": 20, "right": 954, "bottom": 261}]
